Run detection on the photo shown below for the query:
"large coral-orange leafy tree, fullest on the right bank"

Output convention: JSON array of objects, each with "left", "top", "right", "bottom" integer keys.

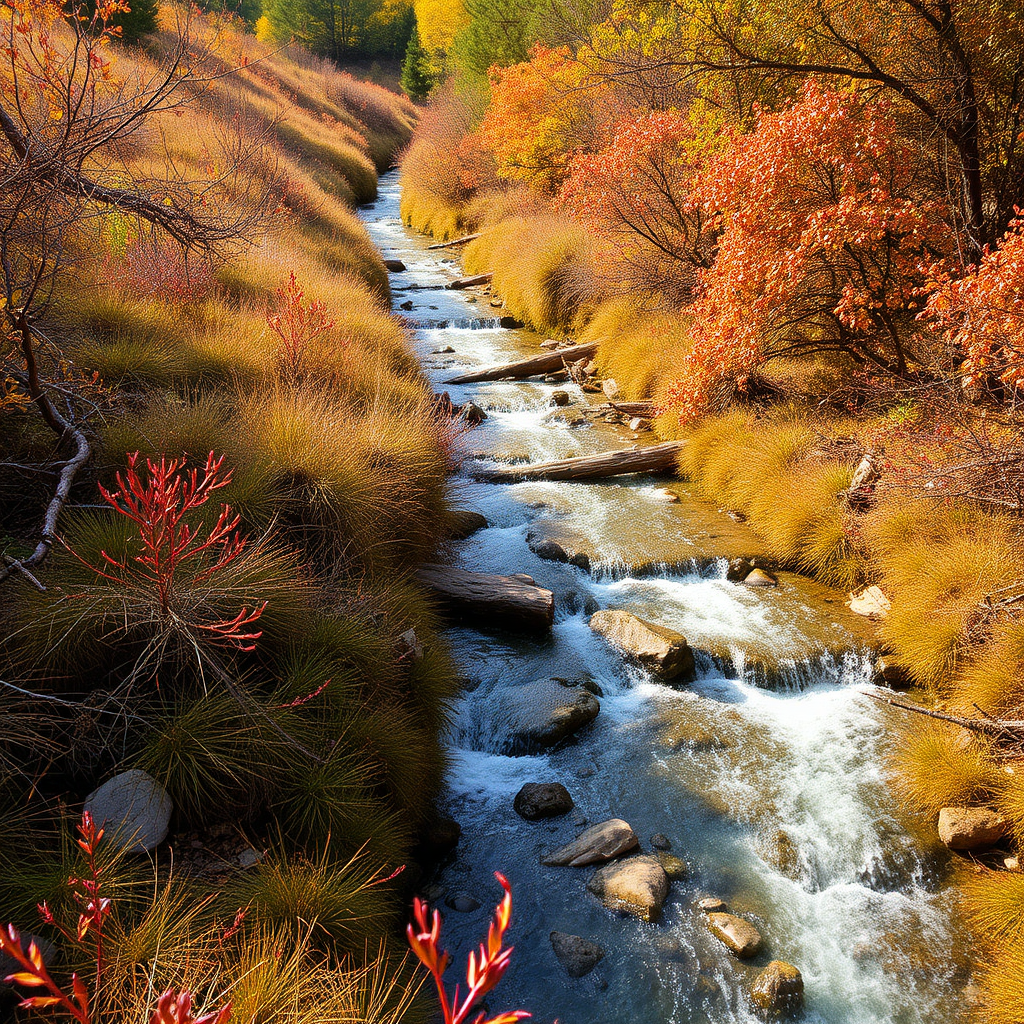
[{"left": 670, "top": 81, "right": 951, "bottom": 418}]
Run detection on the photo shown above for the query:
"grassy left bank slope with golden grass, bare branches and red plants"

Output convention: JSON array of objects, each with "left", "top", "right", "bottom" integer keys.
[{"left": 0, "top": 0, "right": 455, "bottom": 1024}]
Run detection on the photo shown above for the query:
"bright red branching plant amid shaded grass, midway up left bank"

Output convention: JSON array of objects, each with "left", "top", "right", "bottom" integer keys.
[{"left": 79, "top": 452, "right": 266, "bottom": 650}]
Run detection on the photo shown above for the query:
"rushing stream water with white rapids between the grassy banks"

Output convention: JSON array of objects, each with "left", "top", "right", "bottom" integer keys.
[{"left": 362, "top": 173, "right": 968, "bottom": 1024}]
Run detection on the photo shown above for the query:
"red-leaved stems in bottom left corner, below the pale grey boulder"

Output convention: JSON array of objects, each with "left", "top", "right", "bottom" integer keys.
[{"left": 0, "top": 811, "right": 231, "bottom": 1024}]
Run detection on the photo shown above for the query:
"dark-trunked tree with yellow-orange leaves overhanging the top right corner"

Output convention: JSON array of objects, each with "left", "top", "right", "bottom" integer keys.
[{"left": 585, "top": 0, "right": 1024, "bottom": 250}]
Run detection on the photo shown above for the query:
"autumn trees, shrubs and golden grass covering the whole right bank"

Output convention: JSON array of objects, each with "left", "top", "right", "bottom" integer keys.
[{"left": 402, "top": 0, "right": 1024, "bottom": 1011}]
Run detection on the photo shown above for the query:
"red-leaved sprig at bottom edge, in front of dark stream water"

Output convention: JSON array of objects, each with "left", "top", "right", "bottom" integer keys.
[{"left": 406, "top": 871, "right": 530, "bottom": 1024}]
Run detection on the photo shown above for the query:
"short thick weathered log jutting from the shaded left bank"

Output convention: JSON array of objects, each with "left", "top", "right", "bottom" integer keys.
[{"left": 417, "top": 565, "right": 555, "bottom": 633}]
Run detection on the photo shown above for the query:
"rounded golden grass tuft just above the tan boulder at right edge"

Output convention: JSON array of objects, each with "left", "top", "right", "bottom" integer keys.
[{"left": 890, "top": 722, "right": 1005, "bottom": 816}]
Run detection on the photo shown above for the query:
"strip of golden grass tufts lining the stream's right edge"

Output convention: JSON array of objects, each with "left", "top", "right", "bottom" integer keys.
[{"left": 402, "top": 153, "right": 1022, "bottom": 1020}]
